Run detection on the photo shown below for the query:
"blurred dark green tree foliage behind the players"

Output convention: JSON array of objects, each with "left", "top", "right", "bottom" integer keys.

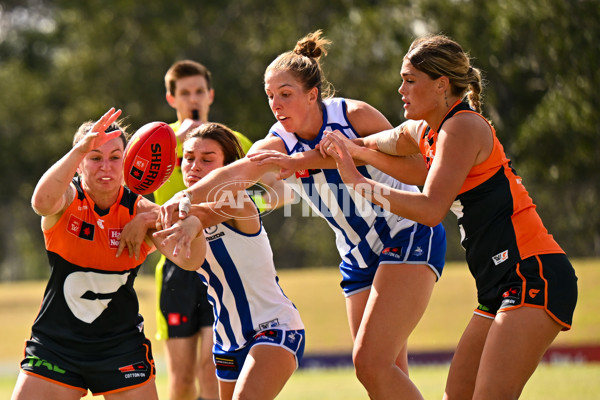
[{"left": 0, "top": 0, "right": 600, "bottom": 280}]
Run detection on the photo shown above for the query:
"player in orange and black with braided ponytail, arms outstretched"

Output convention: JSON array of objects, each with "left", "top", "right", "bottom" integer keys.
[{"left": 321, "top": 35, "right": 577, "bottom": 400}]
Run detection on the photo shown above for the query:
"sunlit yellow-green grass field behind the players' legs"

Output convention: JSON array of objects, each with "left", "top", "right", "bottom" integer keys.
[{"left": 0, "top": 260, "right": 600, "bottom": 400}]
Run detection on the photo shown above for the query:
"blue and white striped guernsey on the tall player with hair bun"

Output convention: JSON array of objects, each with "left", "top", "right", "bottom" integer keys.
[{"left": 270, "top": 98, "right": 419, "bottom": 268}]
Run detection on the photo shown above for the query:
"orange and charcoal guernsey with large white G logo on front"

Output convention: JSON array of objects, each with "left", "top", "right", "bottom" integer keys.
[{"left": 32, "top": 178, "right": 151, "bottom": 357}]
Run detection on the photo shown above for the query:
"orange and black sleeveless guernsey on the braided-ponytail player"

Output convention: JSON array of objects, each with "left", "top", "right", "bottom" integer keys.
[{"left": 419, "top": 102, "right": 564, "bottom": 293}]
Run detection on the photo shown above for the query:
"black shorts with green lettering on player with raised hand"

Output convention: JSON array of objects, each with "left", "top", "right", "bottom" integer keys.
[{"left": 21, "top": 339, "right": 156, "bottom": 396}]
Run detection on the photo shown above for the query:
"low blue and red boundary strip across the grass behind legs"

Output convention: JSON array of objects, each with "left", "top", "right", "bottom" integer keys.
[{"left": 300, "top": 345, "right": 600, "bottom": 369}]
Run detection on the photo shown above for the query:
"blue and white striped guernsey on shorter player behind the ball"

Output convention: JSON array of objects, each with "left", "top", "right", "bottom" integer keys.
[{"left": 198, "top": 219, "right": 304, "bottom": 351}]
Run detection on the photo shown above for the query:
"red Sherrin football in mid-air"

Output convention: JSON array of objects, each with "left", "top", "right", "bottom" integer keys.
[{"left": 123, "top": 122, "right": 177, "bottom": 194}]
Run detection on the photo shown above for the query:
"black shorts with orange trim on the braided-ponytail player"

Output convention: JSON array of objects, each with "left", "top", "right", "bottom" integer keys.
[{"left": 475, "top": 254, "right": 577, "bottom": 330}]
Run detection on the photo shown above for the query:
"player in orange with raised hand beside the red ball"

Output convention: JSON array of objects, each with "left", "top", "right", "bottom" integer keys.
[{"left": 12, "top": 109, "right": 206, "bottom": 400}]
